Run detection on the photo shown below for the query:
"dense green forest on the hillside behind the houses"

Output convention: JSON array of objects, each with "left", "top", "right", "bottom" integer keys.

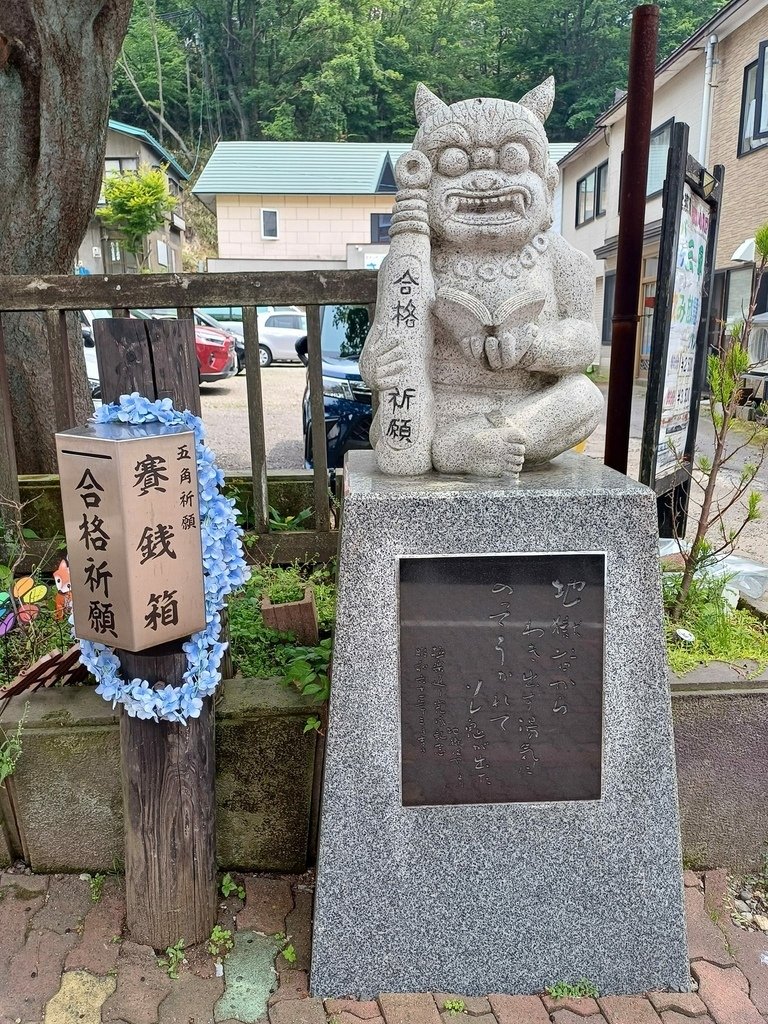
[{"left": 112, "top": 0, "right": 723, "bottom": 167}]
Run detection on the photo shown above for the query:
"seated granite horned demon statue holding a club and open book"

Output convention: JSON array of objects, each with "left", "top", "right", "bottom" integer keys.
[{"left": 360, "top": 78, "right": 602, "bottom": 476}]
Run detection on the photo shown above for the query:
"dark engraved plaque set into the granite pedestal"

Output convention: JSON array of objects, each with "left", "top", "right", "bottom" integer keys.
[{"left": 399, "top": 553, "right": 605, "bottom": 806}]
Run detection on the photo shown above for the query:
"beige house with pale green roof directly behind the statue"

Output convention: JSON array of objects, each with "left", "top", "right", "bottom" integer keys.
[{"left": 194, "top": 142, "right": 570, "bottom": 270}]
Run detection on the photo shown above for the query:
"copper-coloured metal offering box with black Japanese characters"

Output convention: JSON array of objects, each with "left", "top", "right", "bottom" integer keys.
[{"left": 56, "top": 423, "right": 206, "bottom": 651}]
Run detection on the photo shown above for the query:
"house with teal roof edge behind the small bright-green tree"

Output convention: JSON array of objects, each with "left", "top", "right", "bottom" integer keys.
[{"left": 78, "top": 120, "right": 189, "bottom": 273}]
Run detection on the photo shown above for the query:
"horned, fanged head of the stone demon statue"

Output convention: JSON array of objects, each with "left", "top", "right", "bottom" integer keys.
[{"left": 397, "top": 78, "right": 559, "bottom": 250}]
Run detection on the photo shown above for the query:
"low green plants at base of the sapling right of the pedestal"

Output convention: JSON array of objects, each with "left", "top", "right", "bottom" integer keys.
[{"left": 662, "top": 571, "right": 768, "bottom": 676}]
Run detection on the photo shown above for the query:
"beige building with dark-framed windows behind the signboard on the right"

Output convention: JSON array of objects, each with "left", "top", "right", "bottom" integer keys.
[{"left": 560, "top": 0, "right": 768, "bottom": 378}]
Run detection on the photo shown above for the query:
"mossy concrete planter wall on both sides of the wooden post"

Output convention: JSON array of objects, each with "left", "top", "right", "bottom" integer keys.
[{"left": 0, "top": 680, "right": 315, "bottom": 872}]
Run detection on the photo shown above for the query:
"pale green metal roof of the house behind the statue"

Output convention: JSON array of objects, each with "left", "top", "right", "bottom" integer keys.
[{"left": 193, "top": 142, "right": 573, "bottom": 201}]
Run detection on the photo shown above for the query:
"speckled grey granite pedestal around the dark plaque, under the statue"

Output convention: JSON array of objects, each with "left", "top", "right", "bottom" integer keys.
[{"left": 311, "top": 453, "right": 689, "bottom": 998}]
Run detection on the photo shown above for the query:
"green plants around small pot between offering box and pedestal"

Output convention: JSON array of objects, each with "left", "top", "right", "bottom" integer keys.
[{"left": 229, "top": 563, "right": 336, "bottom": 679}]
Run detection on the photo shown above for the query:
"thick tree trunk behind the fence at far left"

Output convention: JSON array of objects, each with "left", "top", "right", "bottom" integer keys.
[{"left": 0, "top": 0, "right": 132, "bottom": 473}]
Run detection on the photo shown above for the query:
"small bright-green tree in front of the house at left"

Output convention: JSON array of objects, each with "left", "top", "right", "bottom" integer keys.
[{"left": 96, "top": 166, "right": 176, "bottom": 265}]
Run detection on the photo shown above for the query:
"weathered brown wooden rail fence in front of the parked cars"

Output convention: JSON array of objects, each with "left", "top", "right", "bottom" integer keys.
[{"left": 0, "top": 270, "right": 377, "bottom": 560}]
